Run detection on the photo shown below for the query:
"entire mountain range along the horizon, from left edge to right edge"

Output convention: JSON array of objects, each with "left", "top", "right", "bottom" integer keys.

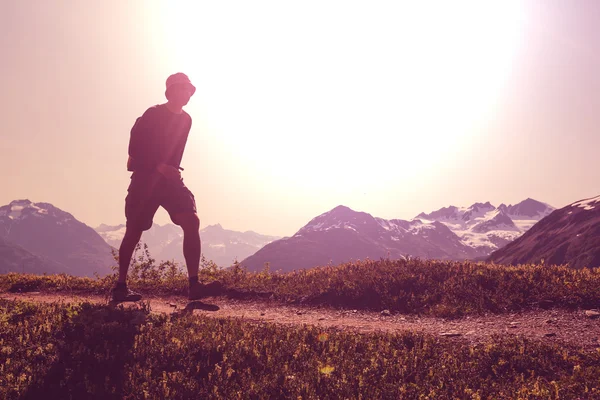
[{"left": 0, "top": 197, "right": 600, "bottom": 276}]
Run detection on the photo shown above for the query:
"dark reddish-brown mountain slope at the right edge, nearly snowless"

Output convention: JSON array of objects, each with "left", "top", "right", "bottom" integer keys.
[{"left": 489, "top": 196, "right": 600, "bottom": 268}]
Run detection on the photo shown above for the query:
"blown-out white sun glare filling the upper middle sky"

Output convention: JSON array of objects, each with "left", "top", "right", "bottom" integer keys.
[{"left": 158, "top": 0, "right": 525, "bottom": 194}]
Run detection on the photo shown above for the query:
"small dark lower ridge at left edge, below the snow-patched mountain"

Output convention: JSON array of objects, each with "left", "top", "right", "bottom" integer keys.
[{"left": 0, "top": 237, "right": 65, "bottom": 274}]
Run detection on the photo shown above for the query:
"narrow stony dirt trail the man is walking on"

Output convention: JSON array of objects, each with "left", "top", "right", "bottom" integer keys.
[{"left": 0, "top": 292, "right": 600, "bottom": 351}]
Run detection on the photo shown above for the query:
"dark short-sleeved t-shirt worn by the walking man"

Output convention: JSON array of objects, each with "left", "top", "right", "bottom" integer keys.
[{"left": 127, "top": 104, "right": 192, "bottom": 172}]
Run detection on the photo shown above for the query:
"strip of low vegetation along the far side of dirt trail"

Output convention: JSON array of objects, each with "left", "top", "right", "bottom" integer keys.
[{"left": 0, "top": 242, "right": 600, "bottom": 317}]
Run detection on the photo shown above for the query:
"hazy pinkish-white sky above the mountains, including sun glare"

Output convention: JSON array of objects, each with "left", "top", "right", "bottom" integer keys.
[{"left": 0, "top": 0, "right": 600, "bottom": 236}]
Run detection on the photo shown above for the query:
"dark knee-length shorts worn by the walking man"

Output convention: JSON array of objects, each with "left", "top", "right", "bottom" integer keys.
[{"left": 125, "top": 172, "right": 196, "bottom": 231}]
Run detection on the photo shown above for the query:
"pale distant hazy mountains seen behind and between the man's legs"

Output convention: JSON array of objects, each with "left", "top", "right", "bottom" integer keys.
[{"left": 96, "top": 224, "right": 279, "bottom": 267}]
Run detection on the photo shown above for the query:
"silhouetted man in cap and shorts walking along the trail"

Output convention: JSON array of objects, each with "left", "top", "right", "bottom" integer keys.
[{"left": 112, "top": 72, "right": 221, "bottom": 301}]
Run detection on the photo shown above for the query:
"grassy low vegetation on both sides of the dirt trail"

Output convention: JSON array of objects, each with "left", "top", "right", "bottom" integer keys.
[{"left": 0, "top": 253, "right": 600, "bottom": 399}]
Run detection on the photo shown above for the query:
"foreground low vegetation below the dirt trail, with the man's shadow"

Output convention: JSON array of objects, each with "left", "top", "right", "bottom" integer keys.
[{"left": 0, "top": 300, "right": 600, "bottom": 399}]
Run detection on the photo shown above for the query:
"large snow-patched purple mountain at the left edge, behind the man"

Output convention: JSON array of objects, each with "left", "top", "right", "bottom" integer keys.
[{"left": 0, "top": 200, "right": 115, "bottom": 276}]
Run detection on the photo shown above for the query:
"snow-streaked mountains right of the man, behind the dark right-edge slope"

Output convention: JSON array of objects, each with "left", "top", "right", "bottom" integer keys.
[{"left": 242, "top": 198, "right": 554, "bottom": 271}]
